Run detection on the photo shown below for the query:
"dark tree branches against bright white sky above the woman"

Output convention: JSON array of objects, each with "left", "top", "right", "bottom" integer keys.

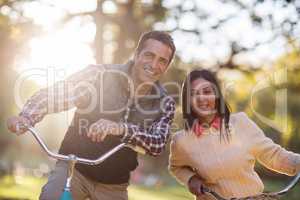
[{"left": 159, "top": 0, "right": 300, "bottom": 71}]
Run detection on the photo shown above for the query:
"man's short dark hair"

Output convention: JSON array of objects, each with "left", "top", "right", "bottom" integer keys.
[{"left": 136, "top": 31, "right": 176, "bottom": 63}]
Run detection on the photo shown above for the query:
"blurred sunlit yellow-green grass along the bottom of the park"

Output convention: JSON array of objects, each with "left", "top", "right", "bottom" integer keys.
[{"left": 0, "top": 176, "right": 300, "bottom": 200}]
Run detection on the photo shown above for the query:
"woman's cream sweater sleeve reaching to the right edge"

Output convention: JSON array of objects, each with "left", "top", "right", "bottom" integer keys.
[{"left": 243, "top": 113, "right": 300, "bottom": 176}]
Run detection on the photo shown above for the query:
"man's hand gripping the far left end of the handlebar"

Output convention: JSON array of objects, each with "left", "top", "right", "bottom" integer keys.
[{"left": 6, "top": 116, "right": 30, "bottom": 135}]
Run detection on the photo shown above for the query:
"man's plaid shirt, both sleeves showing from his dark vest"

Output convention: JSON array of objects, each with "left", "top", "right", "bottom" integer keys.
[{"left": 20, "top": 65, "right": 175, "bottom": 156}]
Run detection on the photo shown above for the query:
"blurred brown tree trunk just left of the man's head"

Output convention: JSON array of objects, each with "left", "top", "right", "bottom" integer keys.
[{"left": 64, "top": 0, "right": 166, "bottom": 63}]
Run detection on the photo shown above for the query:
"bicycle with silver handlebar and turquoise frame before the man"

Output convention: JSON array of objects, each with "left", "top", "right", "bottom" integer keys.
[{"left": 23, "top": 127, "right": 145, "bottom": 200}]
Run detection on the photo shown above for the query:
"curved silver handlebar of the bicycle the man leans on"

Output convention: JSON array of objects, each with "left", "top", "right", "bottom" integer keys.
[{"left": 27, "top": 127, "right": 145, "bottom": 165}]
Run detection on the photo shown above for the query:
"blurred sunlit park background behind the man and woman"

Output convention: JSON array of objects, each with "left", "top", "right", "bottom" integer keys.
[{"left": 0, "top": 0, "right": 300, "bottom": 200}]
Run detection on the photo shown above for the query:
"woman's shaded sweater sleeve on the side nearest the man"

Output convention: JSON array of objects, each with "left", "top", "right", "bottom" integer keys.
[{"left": 168, "top": 133, "right": 196, "bottom": 186}]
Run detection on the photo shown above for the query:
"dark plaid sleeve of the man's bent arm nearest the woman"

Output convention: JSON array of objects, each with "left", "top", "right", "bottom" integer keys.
[{"left": 122, "top": 97, "right": 175, "bottom": 156}]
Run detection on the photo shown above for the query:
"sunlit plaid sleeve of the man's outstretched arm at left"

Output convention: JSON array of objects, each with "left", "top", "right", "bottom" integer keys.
[{"left": 19, "top": 65, "right": 101, "bottom": 126}]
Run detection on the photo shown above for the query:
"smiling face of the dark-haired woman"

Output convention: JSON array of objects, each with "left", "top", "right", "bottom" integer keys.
[{"left": 190, "top": 78, "right": 217, "bottom": 117}]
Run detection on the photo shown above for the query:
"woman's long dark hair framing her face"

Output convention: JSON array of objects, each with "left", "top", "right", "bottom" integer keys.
[{"left": 181, "top": 69, "right": 230, "bottom": 139}]
